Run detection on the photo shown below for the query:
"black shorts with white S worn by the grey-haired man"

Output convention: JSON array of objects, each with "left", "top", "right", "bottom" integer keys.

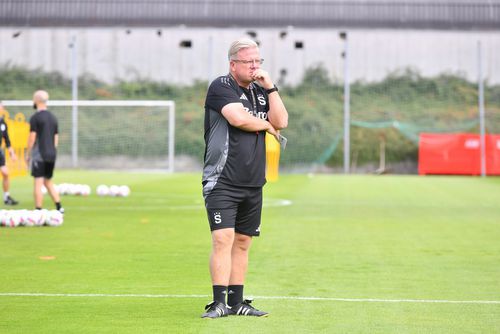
[{"left": 205, "top": 183, "right": 262, "bottom": 237}]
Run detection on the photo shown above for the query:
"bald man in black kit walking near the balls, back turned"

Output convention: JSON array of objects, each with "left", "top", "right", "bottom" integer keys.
[{"left": 26, "top": 90, "right": 64, "bottom": 213}]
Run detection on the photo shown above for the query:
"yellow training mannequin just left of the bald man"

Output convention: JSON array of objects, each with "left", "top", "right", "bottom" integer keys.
[{"left": 0, "top": 107, "right": 30, "bottom": 177}]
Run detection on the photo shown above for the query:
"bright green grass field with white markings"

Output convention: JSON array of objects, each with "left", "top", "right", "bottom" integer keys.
[{"left": 0, "top": 171, "right": 500, "bottom": 334}]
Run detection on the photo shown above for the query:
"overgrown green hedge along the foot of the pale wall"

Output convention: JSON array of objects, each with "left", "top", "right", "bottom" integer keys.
[{"left": 0, "top": 65, "right": 500, "bottom": 166}]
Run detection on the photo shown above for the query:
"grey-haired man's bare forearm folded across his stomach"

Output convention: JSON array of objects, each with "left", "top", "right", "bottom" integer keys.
[{"left": 221, "top": 103, "right": 278, "bottom": 137}]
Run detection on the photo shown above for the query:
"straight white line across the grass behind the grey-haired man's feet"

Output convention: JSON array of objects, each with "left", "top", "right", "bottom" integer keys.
[{"left": 0, "top": 292, "right": 500, "bottom": 304}]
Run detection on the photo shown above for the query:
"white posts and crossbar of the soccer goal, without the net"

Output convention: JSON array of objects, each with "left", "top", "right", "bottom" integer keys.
[{"left": 1, "top": 100, "right": 175, "bottom": 173}]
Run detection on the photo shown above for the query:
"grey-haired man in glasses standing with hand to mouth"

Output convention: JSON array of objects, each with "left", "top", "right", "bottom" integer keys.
[{"left": 201, "top": 38, "right": 288, "bottom": 318}]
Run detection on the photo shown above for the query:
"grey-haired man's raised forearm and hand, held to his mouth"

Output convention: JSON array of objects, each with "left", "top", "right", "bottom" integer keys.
[{"left": 253, "top": 69, "right": 288, "bottom": 130}]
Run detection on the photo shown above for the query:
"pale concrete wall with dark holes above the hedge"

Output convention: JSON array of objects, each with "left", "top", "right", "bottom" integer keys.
[{"left": 0, "top": 26, "right": 500, "bottom": 85}]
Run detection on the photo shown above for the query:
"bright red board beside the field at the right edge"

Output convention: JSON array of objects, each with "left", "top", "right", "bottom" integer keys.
[{"left": 418, "top": 133, "right": 500, "bottom": 175}]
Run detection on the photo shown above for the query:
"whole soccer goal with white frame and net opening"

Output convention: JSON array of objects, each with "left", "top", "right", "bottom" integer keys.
[{"left": 2, "top": 100, "right": 175, "bottom": 172}]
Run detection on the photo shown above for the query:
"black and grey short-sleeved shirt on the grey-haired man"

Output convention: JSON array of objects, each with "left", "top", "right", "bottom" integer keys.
[{"left": 203, "top": 75, "right": 269, "bottom": 195}]
